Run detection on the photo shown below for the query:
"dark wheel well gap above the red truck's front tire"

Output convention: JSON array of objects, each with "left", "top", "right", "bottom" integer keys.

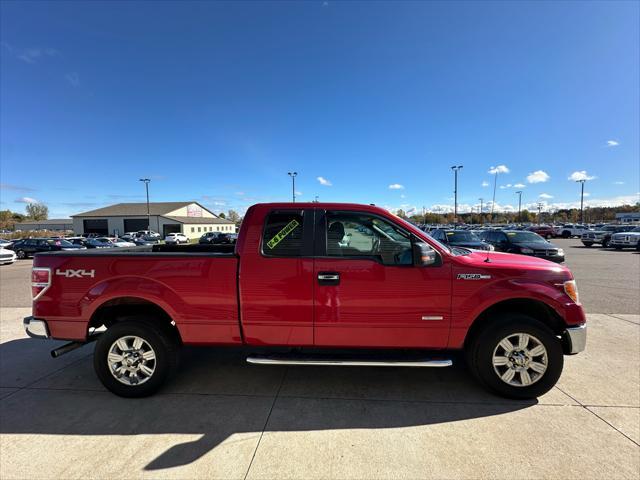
[{"left": 464, "top": 298, "right": 566, "bottom": 348}]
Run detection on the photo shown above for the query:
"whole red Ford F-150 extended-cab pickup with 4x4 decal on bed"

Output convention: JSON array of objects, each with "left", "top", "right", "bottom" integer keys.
[{"left": 24, "top": 203, "right": 586, "bottom": 398}]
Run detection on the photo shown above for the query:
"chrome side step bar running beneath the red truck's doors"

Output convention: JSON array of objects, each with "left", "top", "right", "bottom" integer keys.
[{"left": 247, "top": 355, "right": 453, "bottom": 367}]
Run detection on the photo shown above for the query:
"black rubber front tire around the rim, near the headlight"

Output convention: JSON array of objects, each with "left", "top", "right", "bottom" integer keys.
[{"left": 466, "top": 313, "right": 564, "bottom": 399}]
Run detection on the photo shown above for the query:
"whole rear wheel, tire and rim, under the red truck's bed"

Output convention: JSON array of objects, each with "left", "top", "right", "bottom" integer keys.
[{"left": 93, "top": 320, "right": 178, "bottom": 398}]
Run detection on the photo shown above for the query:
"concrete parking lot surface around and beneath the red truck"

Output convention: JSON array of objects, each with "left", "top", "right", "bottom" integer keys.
[{"left": 0, "top": 240, "right": 640, "bottom": 479}]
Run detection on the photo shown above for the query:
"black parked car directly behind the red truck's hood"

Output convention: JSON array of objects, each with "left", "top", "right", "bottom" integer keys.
[{"left": 482, "top": 230, "right": 564, "bottom": 263}]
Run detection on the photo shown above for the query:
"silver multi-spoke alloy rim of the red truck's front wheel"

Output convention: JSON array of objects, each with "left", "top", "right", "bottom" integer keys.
[{"left": 492, "top": 333, "right": 549, "bottom": 387}]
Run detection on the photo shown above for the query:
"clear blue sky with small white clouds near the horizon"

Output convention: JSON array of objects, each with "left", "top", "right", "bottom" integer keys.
[{"left": 0, "top": 1, "right": 640, "bottom": 217}]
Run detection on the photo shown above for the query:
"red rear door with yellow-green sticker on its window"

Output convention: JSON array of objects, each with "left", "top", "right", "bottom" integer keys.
[{"left": 239, "top": 209, "right": 314, "bottom": 346}]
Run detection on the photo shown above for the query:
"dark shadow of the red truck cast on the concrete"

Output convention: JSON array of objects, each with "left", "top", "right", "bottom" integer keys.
[{"left": 0, "top": 339, "right": 537, "bottom": 471}]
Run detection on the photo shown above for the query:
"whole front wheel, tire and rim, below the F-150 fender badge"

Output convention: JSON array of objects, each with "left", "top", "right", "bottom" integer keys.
[{"left": 467, "top": 313, "right": 564, "bottom": 399}]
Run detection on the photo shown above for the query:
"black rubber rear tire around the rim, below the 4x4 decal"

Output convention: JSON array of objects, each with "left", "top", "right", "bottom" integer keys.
[{"left": 93, "top": 318, "right": 179, "bottom": 398}]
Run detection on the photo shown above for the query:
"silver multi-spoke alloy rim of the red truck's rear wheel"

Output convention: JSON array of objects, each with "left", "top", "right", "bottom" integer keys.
[{"left": 107, "top": 335, "right": 156, "bottom": 386}]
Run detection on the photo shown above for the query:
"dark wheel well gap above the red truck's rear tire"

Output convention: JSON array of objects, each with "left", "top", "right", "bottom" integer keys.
[{"left": 87, "top": 297, "right": 182, "bottom": 344}]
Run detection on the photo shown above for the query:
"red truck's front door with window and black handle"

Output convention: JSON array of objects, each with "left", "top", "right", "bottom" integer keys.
[{"left": 314, "top": 211, "right": 451, "bottom": 348}]
